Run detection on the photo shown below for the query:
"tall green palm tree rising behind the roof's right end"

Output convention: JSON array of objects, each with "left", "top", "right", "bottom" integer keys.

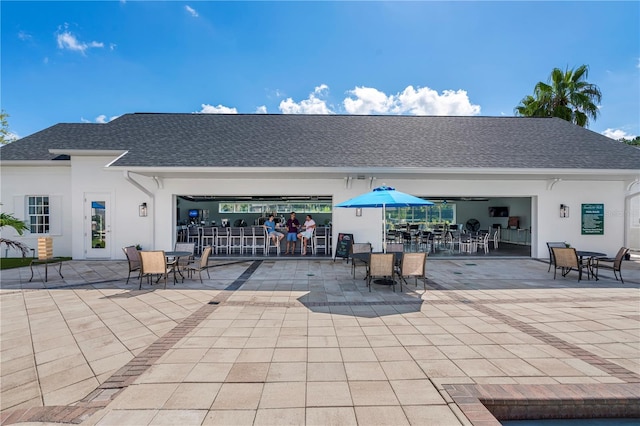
[{"left": 515, "top": 65, "right": 602, "bottom": 127}]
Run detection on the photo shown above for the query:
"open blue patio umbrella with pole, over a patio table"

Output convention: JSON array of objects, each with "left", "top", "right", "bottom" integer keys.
[{"left": 335, "top": 186, "right": 434, "bottom": 253}]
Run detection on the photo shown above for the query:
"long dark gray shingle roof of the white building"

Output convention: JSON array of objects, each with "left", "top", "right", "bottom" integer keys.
[{"left": 0, "top": 113, "right": 640, "bottom": 170}]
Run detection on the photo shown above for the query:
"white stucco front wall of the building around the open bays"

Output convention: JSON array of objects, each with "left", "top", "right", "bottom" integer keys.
[{"left": 0, "top": 156, "right": 640, "bottom": 259}]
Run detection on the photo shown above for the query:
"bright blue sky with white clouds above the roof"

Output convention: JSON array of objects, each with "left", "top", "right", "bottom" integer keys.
[{"left": 0, "top": 0, "right": 640, "bottom": 139}]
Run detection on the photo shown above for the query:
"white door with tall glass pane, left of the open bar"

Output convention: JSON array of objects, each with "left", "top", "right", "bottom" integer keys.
[{"left": 84, "top": 192, "right": 113, "bottom": 259}]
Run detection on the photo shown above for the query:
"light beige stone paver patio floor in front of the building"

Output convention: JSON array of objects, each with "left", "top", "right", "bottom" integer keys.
[{"left": 0, "top": 258, "right": 640, "bottom": 425}]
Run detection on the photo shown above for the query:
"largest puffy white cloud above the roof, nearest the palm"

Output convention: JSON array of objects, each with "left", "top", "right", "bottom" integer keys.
[{"left": 343, "top": 86, "right": 480, "bottom": 116}]
